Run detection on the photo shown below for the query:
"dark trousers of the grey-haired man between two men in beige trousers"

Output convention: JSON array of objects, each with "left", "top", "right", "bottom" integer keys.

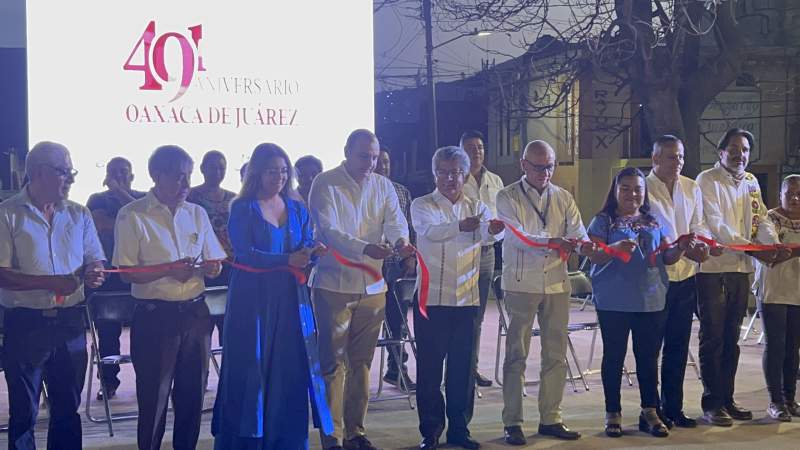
[{"left": 414, "top": 306, "right": 479, "bottom": 438}]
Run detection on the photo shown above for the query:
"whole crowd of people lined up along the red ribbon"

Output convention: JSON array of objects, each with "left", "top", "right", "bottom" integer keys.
[{"left": 0, "top": 128, "right": 800, "bottom": 450}]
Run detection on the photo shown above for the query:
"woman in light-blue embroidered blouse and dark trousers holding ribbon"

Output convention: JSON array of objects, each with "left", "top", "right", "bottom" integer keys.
[{"left": 586, "top": 167, "right": 695, "bottom": 437}]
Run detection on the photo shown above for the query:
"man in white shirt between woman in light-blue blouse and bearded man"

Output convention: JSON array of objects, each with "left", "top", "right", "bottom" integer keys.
[{"left": 647, "top": 135, "right": 721, "bottom": 428}]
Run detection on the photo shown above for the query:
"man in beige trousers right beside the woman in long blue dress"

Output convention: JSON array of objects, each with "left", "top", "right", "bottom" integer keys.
[{"left": 309, "top": 130, "right": 413, "bottom": 450}]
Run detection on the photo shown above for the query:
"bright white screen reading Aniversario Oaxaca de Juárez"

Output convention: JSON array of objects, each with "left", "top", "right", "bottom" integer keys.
[{"left": 26, "top": 0, "right": 374, "bottom": 202}]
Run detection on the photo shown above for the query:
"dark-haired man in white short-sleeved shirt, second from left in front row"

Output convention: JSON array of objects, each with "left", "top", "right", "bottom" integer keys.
[{"left": 113, "top": 145, "right": 227, "bottom": 450}]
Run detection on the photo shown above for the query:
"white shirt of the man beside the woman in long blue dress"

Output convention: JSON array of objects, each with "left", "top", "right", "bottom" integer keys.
[{"left": 308, "top": 164, "right": 408, "bottom": 295}]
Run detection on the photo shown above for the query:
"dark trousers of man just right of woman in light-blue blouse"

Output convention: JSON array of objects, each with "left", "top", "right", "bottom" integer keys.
[{"left": 661, "top": 277, "right": 697, "bottom": 417}]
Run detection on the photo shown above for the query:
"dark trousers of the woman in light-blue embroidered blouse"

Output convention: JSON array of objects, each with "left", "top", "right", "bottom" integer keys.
[{"left": 597, "top": 310, "right": 667, "bottom": 412}]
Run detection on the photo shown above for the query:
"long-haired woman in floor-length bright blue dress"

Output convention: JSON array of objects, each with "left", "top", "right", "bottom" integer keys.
[{"left": 212, "top": 144, "right": 333, "bottom": 450}]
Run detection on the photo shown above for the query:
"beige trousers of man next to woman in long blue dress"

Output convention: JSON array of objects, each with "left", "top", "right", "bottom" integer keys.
[{"left": 311, "top": 289, "right": 386, "bottom": 449}]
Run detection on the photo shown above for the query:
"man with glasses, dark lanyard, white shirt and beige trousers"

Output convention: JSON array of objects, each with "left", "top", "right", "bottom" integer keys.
[{"left": 497, "top": 141, "right": 594, "bottom": 445}]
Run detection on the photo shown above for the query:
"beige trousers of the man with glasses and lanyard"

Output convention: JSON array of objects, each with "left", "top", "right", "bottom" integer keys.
[{"left": 503, "top": 291, "right": 569, "bottom": 427}]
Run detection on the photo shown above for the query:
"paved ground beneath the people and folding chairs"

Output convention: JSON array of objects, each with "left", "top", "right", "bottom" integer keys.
[{"left": 0, "top": 305, "right": 800, "bottom": 450}]
